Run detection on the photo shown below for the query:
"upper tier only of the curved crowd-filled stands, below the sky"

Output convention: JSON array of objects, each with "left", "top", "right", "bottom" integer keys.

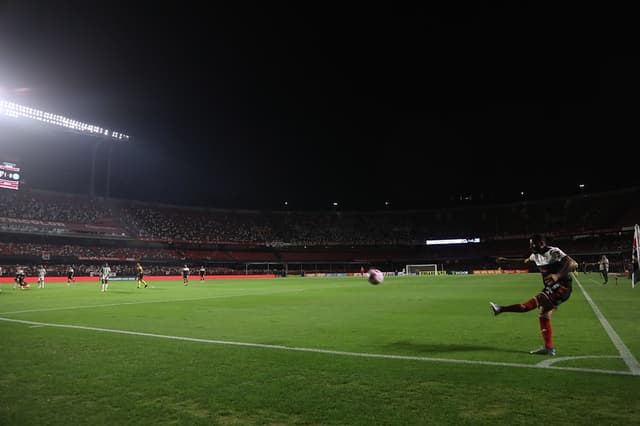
[{"left": 0, "top": 189, "right": 640, "bottom": 246}]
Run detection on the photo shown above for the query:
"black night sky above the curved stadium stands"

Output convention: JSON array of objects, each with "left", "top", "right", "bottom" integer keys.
[{"left": 0, "top": 0, "right": 640, "bottom": 210}]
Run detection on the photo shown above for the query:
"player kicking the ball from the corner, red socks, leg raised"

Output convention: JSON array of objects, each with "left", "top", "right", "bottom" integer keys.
[{"left": 489, "top": 235, "right": 578, "bottom": 355}]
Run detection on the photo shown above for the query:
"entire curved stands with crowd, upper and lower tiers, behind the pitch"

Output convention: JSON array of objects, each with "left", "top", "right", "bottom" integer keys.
[{"left": 0, "top": 188, "right": 640, "bottom": 274}]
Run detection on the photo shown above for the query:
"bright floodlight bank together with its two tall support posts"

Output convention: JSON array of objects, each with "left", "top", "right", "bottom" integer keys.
[{"left": 0, "top": 99, "right": 131, "bottom": 197}]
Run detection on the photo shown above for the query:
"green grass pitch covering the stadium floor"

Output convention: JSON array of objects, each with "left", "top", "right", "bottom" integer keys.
[{"left": 0, "top": 274, "right": 640, "bottom": 425}]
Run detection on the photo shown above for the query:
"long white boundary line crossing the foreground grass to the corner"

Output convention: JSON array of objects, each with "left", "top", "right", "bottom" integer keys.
[{"left": 0, "top": 317, "right": 633, "bottom": 376}]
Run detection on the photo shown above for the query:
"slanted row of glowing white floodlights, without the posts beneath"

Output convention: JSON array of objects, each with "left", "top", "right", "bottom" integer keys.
[{"left": 0, "top": 99, "right": 130, "bottom": 141}]
